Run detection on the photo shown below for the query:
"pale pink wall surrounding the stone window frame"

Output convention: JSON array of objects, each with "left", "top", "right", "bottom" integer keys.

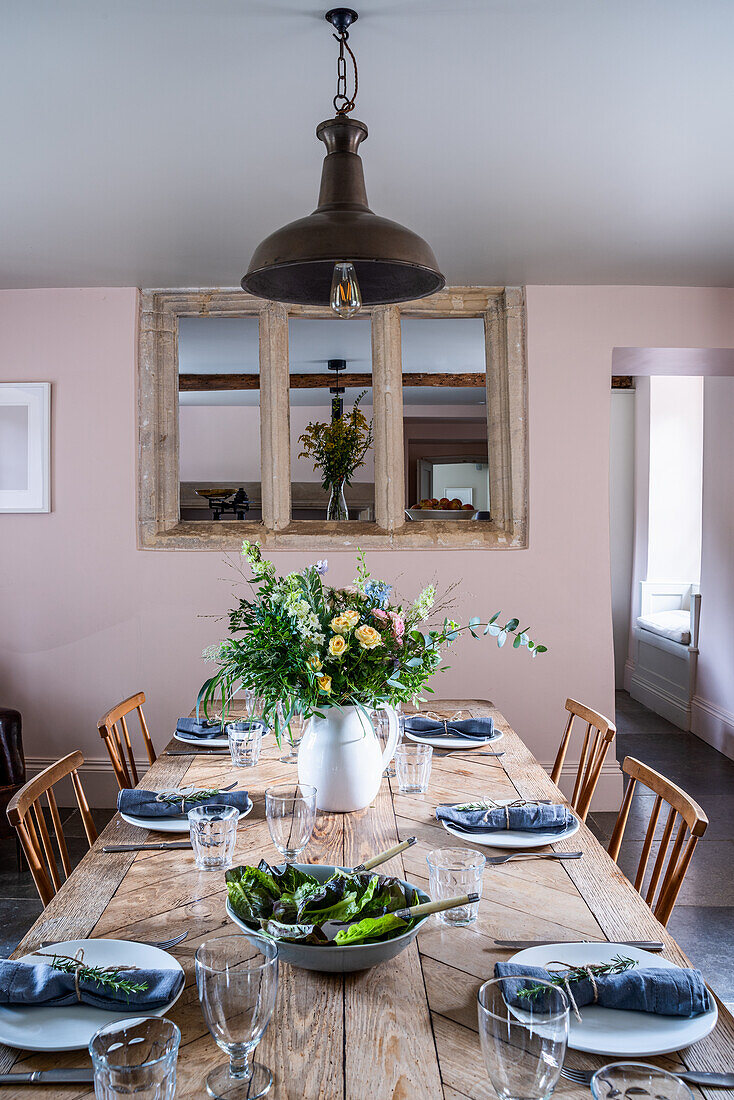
[{"left": 0, "top": 287, "right": 734, "bottom": 809}]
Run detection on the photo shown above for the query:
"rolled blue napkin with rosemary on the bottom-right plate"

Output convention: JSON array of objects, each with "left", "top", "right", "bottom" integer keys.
[{"left": 494, "top": 963, "right": 711, "bottom": 1018}]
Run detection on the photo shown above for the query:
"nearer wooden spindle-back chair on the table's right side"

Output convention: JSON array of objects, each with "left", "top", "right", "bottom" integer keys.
[{"left": 609, "top": 757, "right": 709, "bottom": 924}]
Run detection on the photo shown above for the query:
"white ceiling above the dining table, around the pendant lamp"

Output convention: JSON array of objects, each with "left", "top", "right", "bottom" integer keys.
[{"left": 0, "top": 0, "right": 734, "bottom": 287}]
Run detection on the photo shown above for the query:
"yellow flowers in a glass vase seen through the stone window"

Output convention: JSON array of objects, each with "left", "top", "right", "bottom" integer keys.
[{"left": 298, "top": 391, "right": 372, "bottom": 519}]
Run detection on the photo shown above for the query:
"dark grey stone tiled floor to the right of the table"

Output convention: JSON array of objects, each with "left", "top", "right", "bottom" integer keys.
[{"left": 589, "top": 691, "right": 734, "bottom": 1002}]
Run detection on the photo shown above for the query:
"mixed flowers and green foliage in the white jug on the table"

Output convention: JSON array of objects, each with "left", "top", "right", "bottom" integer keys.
[{"left": 199, "top": 542, "right": 546, "bottom": 744}]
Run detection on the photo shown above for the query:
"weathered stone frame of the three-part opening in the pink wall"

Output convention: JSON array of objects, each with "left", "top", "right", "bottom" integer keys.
[{"left": 138, "top": 287, "right": 528, "bottom": 552}]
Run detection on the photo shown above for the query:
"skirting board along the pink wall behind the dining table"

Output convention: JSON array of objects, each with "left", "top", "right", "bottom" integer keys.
[{"left": 25, "top": 743, "right": 622, "bottom": 812}]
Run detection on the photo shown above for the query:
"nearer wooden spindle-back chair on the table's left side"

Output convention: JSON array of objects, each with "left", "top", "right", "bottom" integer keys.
[{"left": 8, "top": 751, "right": 97, "bottom": 905}]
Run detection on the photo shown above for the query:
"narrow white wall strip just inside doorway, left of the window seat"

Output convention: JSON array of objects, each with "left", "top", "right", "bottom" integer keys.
[{"left": 610, "top": 389, "right": 635, "bottom": 688}]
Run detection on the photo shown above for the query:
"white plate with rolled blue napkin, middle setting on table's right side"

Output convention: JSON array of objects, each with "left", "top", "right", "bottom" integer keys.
[{"left": 436, "top": 796, "right": 580, "bottom": 844}]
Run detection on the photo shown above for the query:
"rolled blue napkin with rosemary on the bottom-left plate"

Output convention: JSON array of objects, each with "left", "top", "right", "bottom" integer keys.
[{"left": 0, "top": 949, "right": 184, "bottom": 1013}]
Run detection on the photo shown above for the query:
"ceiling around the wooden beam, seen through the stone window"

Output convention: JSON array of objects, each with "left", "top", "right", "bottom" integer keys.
[{"left": 178, "top": 317, "right": 485, "bottom": 405}]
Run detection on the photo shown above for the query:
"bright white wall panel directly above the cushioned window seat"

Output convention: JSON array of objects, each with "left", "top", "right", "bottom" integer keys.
[{"left": 646, "top": 377, "right": 703, "bottom": 584}]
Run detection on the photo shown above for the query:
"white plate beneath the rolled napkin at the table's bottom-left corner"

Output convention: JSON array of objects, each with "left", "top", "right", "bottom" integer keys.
[{"left": 0, "top": 939, "right": 184, "bottom": 1051}]
